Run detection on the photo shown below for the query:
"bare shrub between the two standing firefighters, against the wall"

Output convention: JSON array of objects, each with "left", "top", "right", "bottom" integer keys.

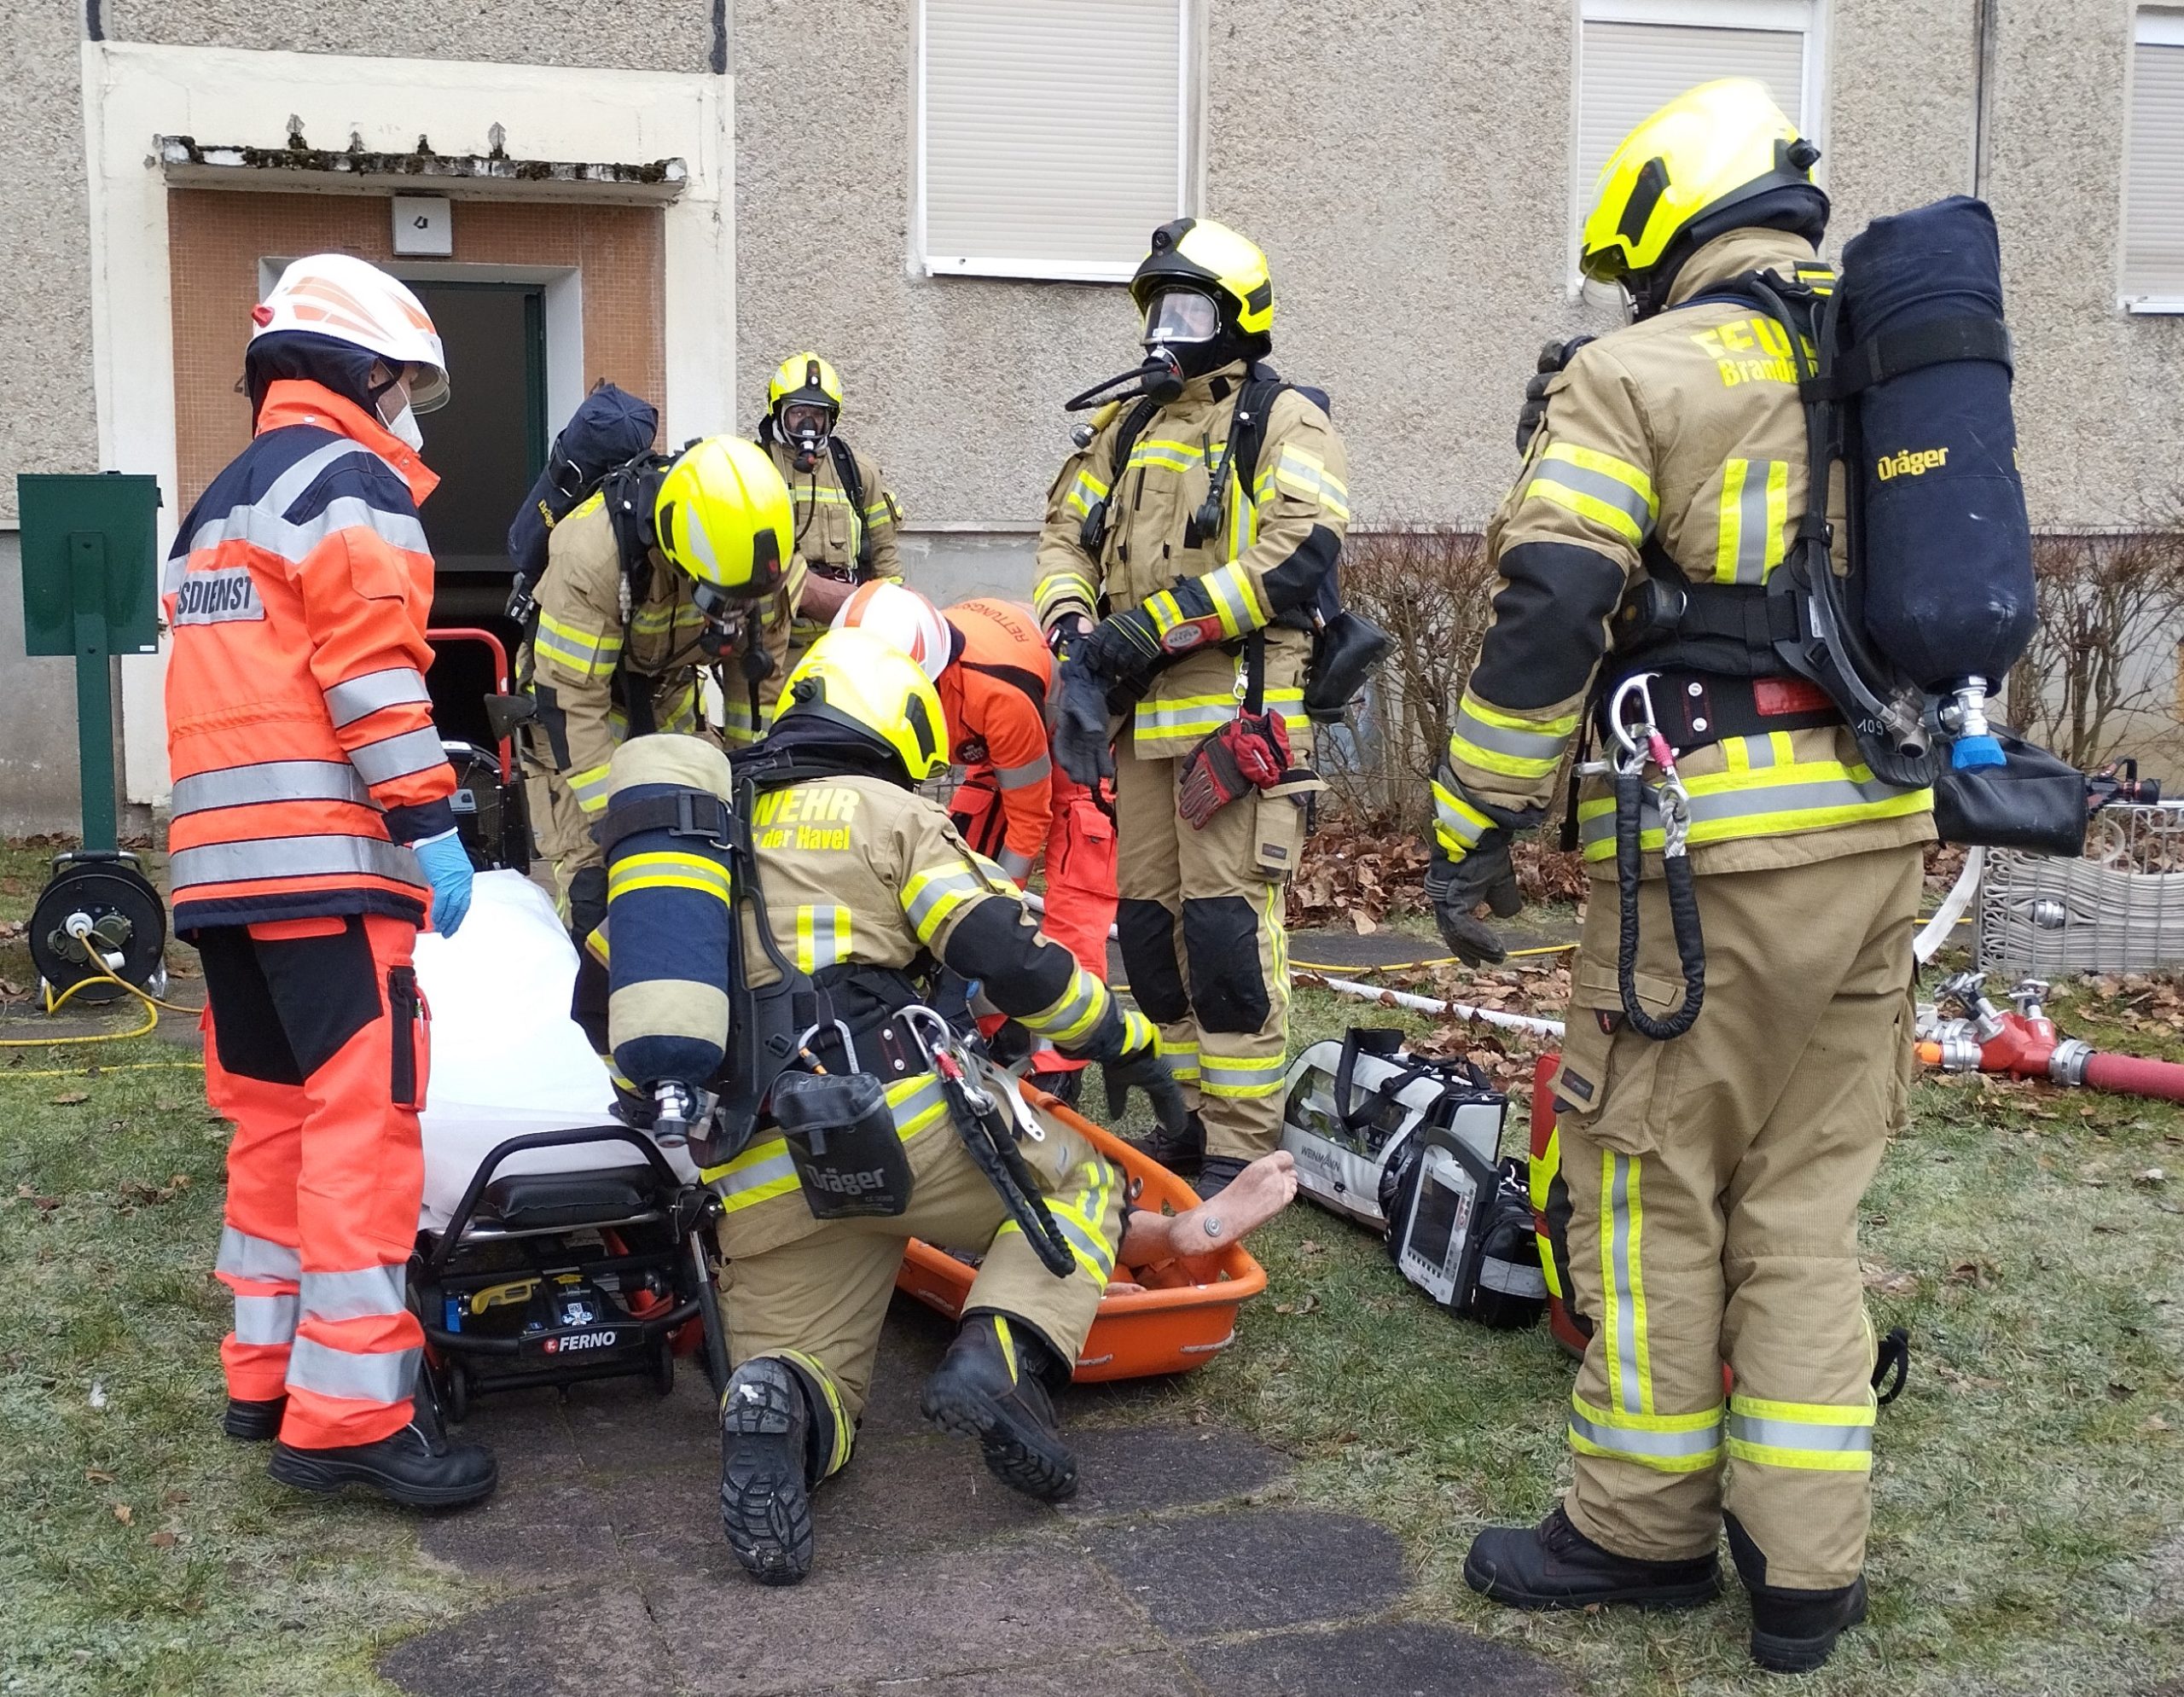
[{"left": 1319, "top": 524, "right": 1494, "bottom": 830}]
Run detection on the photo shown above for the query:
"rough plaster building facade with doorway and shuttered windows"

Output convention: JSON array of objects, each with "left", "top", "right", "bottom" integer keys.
[{"left": 0, "top": 0, "right": 2184, "bottom": 830}]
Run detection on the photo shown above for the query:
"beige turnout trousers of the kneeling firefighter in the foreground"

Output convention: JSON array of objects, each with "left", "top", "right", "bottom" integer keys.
[{"left": 721, "top": 1085, "right": 1123, "bottom": 1472}]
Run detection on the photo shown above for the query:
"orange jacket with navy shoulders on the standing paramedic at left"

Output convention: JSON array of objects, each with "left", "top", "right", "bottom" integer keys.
[{"left": 161, "top": 380, "right": 454, "bottom": 935}]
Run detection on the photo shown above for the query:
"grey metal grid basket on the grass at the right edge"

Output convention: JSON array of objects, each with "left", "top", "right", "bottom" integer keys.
[{"left": 1978, "top": 804, "right": 2184, "bottom": 979}]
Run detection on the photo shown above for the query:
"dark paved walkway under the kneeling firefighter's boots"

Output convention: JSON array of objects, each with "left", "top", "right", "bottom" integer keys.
[{"left": 380, "top": 1302, "right": 1571, "bottom": 1697}]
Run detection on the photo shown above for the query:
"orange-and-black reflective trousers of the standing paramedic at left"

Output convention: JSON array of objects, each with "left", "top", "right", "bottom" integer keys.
[{"left": 196, "top": 913, "right": 430, "bottom": 1450}]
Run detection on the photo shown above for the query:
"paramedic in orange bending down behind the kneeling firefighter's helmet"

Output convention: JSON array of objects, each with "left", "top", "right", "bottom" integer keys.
[{"left": 834, "top": 583, "right": 1116, "bottom": 1103}]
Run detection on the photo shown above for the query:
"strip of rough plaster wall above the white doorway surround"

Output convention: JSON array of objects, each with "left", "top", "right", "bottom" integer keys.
[{"left": 105, "top": 0, "right": 714, "bottom": 70}]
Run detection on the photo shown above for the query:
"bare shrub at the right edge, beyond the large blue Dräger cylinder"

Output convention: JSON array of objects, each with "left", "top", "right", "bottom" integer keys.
[{"left": 2009, "top": 524, "right": 2184, "bottom": 769}]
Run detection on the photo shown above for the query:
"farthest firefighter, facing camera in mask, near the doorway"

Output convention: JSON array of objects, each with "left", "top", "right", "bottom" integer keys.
[{"left": 758, "top": 354, "right": 902, "bottom": 668}]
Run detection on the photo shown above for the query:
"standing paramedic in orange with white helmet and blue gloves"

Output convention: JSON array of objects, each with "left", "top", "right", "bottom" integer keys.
[{"left": 161, "top": 253, "right": 496, "bottom": 1507}]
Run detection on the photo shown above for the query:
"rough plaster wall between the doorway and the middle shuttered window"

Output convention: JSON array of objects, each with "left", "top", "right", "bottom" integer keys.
[{"left": 736, "top": 0, "right": 1138, "bottom": 543}]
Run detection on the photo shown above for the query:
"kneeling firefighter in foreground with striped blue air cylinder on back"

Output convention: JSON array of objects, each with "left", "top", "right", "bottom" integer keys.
[{"left": 603, "top": 631, "right": 1158, "bottom": 1584}]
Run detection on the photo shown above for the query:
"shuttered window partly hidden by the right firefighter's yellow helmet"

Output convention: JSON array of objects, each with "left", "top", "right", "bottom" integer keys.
[{"left": 1571, "top": 0, "right": 1824, "bottom": 286}]
